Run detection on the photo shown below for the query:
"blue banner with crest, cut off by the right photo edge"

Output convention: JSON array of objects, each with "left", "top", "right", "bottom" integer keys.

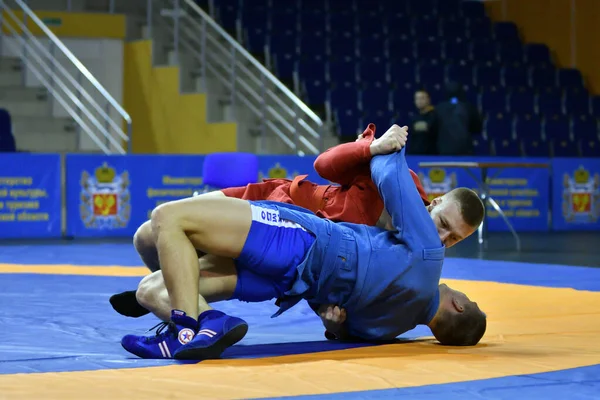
[{"left": 552, "top": 158, "right": 600, "bottom": 231}]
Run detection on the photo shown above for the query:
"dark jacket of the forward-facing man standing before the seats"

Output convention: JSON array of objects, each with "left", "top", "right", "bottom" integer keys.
[{"left": 406, "top": 106, "right": 438, "bottom": 155}]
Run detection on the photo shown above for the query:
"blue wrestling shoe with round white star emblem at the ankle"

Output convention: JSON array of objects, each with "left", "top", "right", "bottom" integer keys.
[{"left": 121, "top": 310, "right": 198, "bottom": 358}]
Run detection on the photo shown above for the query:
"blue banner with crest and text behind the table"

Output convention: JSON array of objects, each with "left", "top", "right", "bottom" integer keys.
[{"left": 407, "top": 156, "right": 550, "bottom": 232}]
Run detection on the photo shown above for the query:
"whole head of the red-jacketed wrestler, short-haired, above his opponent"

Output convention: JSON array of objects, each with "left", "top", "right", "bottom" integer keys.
[{"left": 427, "top": 188, "right": 485, "bottom": 247}]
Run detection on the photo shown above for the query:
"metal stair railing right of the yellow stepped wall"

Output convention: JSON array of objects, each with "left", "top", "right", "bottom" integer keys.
[{"left": 146, "top": 0, "right": 326, "bottom": 155}]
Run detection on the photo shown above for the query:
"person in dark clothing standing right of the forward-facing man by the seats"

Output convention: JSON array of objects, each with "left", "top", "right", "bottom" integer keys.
[{"left": 436, "top": 82, "right": 482, "bottom": 156}]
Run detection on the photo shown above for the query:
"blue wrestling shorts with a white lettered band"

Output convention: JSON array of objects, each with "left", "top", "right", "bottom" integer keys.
[{"left": 232, "top": 201, "right": 315, "bottom": 302}]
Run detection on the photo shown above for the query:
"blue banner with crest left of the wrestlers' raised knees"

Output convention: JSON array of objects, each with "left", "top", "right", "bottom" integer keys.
[{"left": 66, "top": 154, "right": 204, "bottom": 237}]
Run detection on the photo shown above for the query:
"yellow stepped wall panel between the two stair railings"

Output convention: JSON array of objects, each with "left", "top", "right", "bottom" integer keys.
[{"left": 124, "top": 41, "right": 237, "bottom": 154}]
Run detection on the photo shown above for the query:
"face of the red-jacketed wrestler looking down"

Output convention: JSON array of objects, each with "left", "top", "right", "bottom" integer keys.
[{"left": 427, "top": 194, "right": 475, "bottom": 247}]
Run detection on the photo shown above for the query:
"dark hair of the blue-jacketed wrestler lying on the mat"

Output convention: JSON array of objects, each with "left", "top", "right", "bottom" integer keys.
[{"left": 432, "top": 304, "right": 487, "bottom": 346}]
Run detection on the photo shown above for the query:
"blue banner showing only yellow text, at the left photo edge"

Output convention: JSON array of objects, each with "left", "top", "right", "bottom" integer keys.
[{"left": 0, "top": 153, "right": 61, "bottom": 239}]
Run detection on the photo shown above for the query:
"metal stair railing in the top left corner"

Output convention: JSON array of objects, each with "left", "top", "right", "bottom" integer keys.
[{"left": 0, "top": 0, "right": 131, "bottom": 154}]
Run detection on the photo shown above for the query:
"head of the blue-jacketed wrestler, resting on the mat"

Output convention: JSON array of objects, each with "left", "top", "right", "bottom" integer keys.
[{"left": 428, "top": 284, "right": 487, "bottom": 346}]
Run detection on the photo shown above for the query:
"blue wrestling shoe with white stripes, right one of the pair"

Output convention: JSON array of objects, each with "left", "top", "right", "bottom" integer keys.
[{"left": 173, "top": 310, "right": 248, "bottom": 361}]
